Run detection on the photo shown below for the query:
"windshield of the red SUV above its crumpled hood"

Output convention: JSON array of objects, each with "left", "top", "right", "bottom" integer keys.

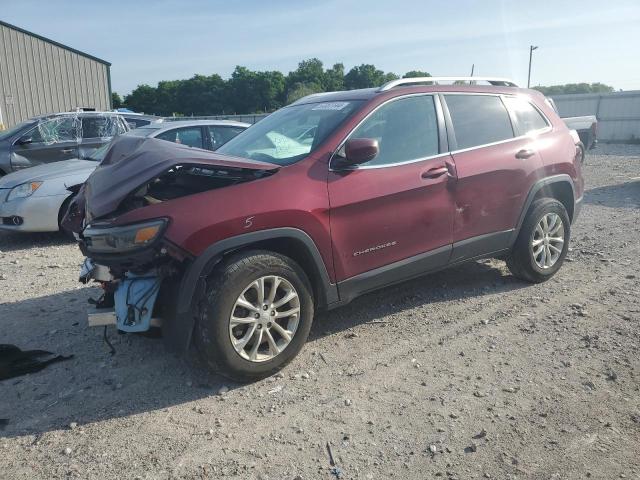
[{"left": 217, "top": 100, "right": 363, "bottom": 165}]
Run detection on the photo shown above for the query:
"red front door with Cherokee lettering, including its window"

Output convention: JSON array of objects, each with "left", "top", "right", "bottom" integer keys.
[{"left": 328, "top": 95, "right": 453, "bottom": 296}]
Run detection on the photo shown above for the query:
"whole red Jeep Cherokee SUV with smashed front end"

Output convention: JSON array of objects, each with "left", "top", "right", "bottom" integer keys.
[{"left": 71, "top": 78, "right": 583, "bottom": 379}]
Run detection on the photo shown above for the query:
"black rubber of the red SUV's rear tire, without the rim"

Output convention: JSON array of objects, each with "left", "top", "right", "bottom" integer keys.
[{"left": 507, "top": 198, "right": 571, "bottom": 283}]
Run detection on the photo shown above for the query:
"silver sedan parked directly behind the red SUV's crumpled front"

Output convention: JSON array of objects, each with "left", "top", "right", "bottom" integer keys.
[{"left": 0, "top": 120, "right": 249, "bottom": 232}]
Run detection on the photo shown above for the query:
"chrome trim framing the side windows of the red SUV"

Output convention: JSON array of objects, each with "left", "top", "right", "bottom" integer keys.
[{"left": 329, "top": 92, "right": 553, "bottom": 172}]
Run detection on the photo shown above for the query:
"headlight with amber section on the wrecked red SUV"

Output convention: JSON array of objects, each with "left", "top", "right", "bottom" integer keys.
[{"left": 82, "top": 219, "right": 167, "bottom": 253}]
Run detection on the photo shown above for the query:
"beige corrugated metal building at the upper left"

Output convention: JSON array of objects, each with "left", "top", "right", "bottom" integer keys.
[{"left": 0, "top": 21, "right": 111, "bottom": 130}]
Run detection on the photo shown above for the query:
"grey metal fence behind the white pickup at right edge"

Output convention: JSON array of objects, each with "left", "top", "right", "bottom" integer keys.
[{"left": 553, "top": 90, "right": 640, "bottom": 142}]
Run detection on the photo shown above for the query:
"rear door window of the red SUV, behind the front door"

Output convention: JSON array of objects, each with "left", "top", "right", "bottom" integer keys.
[{"left": 444, "top": 95, "right": 514, "bottom": 149}]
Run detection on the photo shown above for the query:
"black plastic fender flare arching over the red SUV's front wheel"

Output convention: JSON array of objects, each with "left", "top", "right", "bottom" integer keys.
[{"left": 163, "top": 227, "right": 339, "bottom": 353}]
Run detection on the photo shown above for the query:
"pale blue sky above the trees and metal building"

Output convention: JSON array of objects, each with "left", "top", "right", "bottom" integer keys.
[{"left": 0, "top": 0, "right": 640, "bottom": 95}]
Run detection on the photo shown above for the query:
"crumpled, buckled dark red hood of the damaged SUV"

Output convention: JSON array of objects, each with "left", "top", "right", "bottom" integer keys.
[{"left": 83, "top": 135, "right": 279, "bottom": 218}]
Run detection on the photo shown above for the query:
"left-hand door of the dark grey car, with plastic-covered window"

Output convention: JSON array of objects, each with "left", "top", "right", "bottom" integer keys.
[{"left": 11, "top": 115, "right": 80, "bottom": 169}]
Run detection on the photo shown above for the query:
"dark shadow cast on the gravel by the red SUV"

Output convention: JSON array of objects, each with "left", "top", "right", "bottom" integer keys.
[{"left": 0, "top": 260, "right": 527, "bottom": 442}]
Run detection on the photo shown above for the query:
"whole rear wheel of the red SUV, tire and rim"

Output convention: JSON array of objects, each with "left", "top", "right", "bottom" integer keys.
[{"left": 507, "top": 198, "right": 571, "bottom": 283}]
